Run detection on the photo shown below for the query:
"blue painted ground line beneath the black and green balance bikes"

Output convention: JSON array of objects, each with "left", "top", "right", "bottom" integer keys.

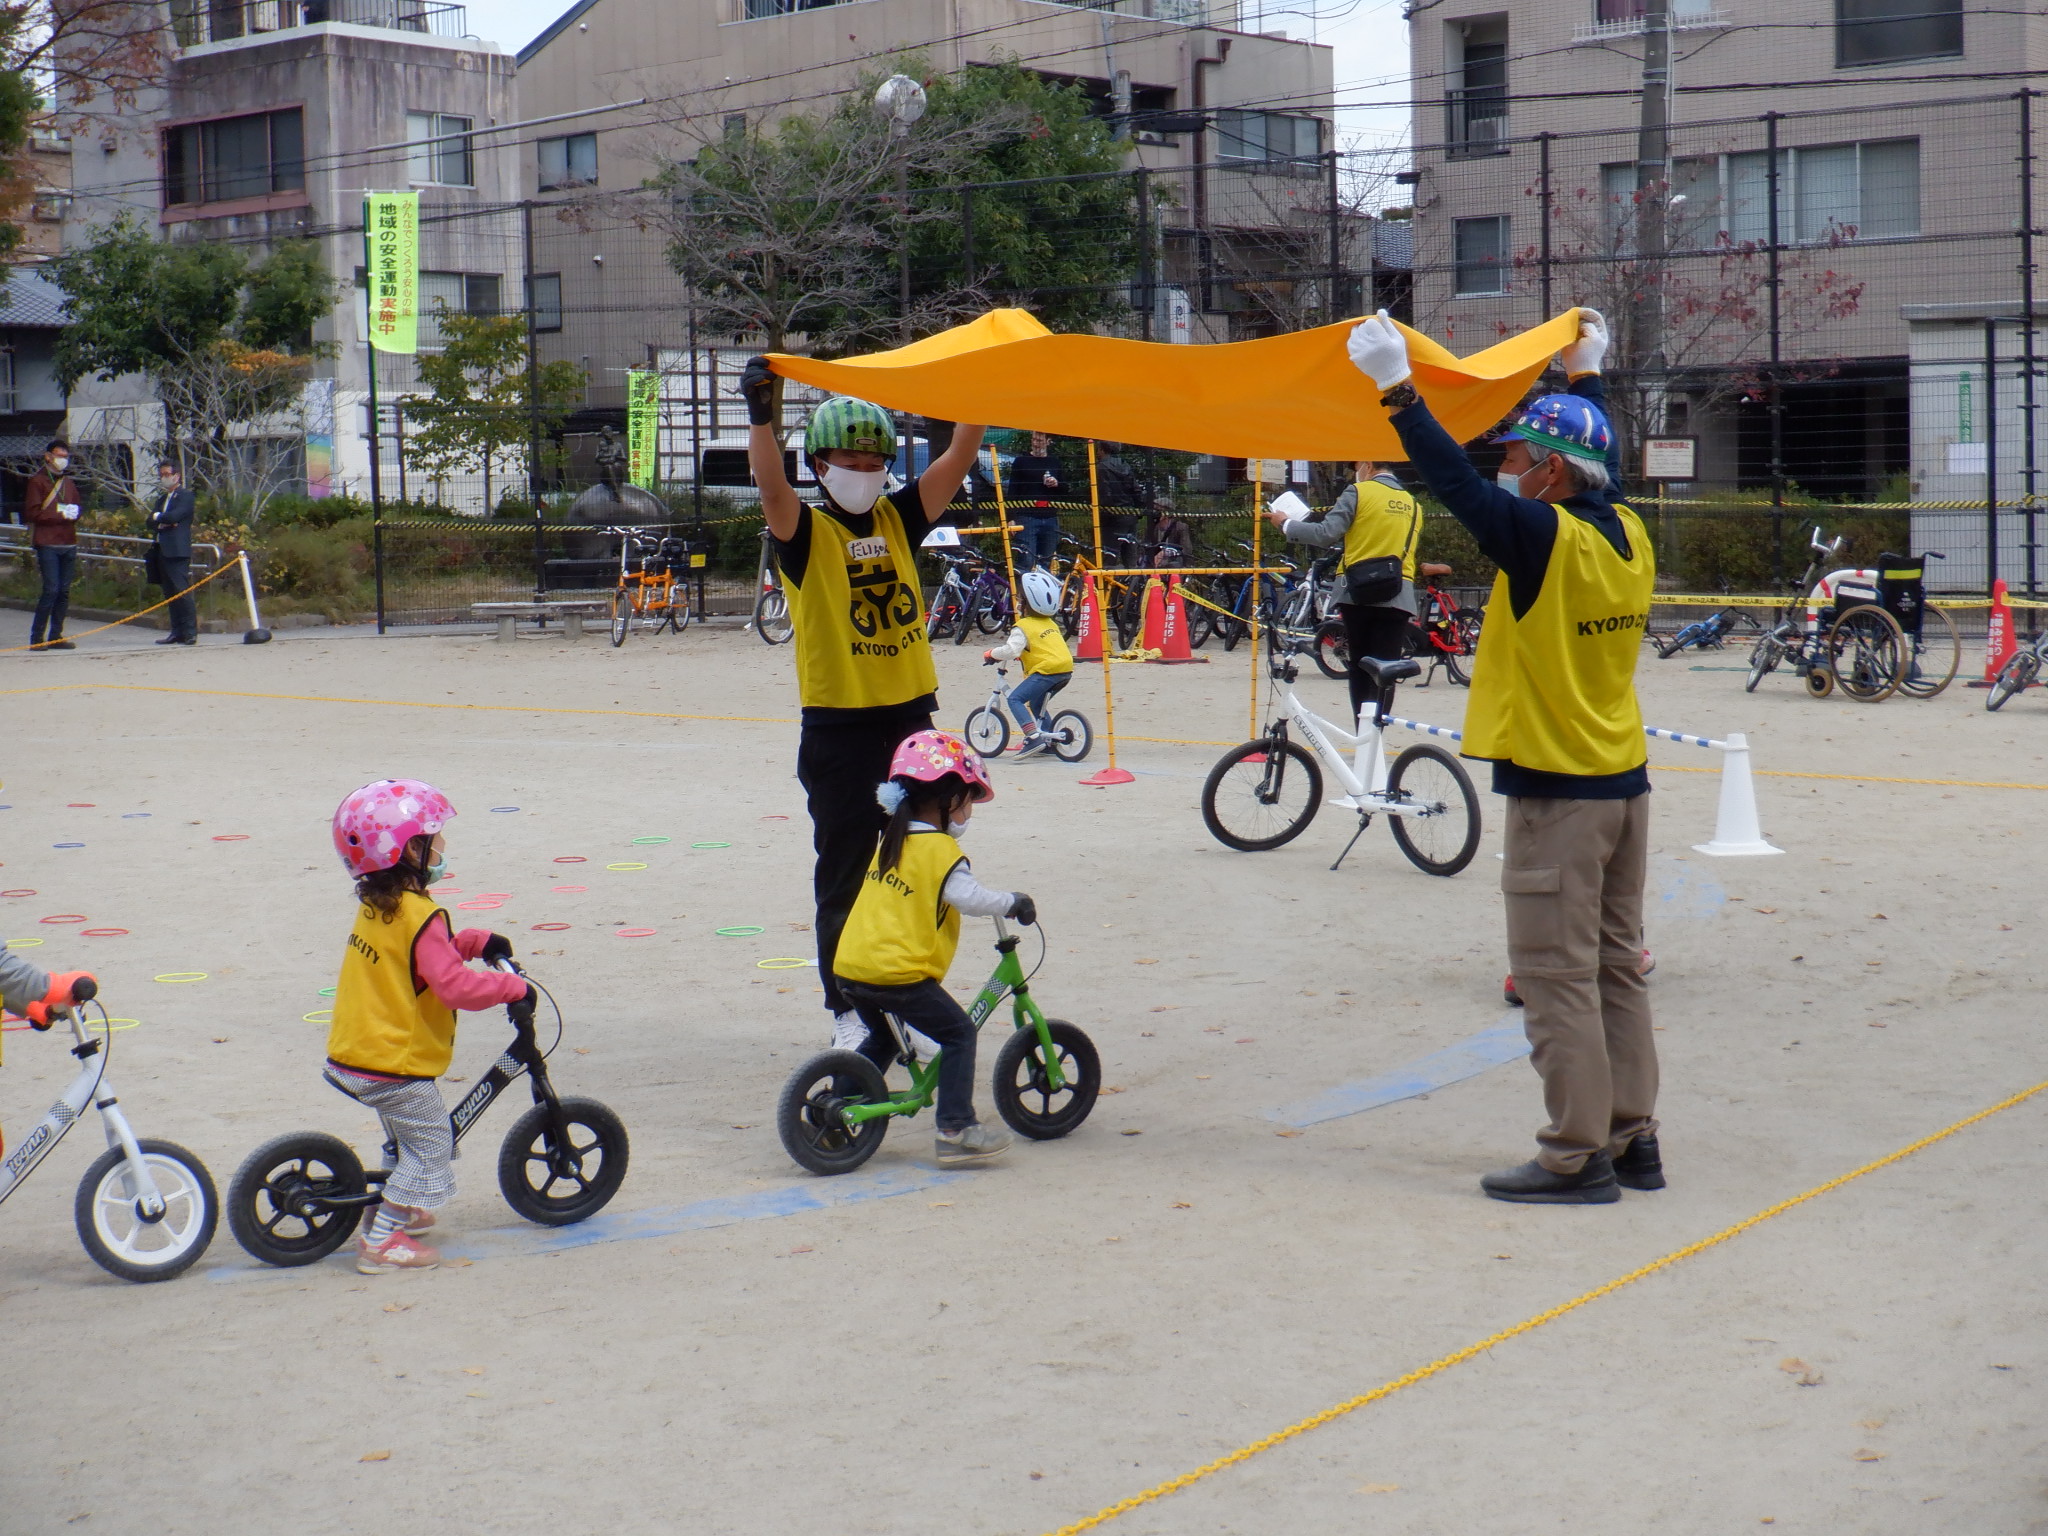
[{"left": 211, "top": 1163, "right": 969, "bottom": 1280}]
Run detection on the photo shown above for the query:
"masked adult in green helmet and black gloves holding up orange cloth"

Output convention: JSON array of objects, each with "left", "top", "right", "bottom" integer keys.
[{"left": 739, "top": 356, "right": 981, "bottom": 1047}]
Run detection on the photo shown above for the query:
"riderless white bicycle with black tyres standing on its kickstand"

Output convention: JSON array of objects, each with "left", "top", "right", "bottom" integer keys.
[{"left": 1202, "top": 655, "right": 1479, "bottom": 874}]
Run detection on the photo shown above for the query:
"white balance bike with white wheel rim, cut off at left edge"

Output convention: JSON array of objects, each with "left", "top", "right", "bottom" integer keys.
[{"left": 0, "top": 979, "right": 221, "bottom": 1280}]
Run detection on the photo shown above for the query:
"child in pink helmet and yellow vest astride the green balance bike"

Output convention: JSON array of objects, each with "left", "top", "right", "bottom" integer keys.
[{"left": 834, "top": 731, "right": 1038, "bottom": 1167}]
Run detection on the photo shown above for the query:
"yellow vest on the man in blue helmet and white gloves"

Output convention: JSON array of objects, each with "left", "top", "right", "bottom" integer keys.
[{"left": 1464, "top": 502, "right": 1657, "bottom": 778}]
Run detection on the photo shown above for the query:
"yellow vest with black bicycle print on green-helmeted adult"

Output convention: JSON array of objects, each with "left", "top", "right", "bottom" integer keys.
[{"left": 788, "top": 496, "right": 938, "bottom": 709}]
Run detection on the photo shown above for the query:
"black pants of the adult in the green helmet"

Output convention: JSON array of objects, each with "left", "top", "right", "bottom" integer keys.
[{"left": 797, "top": 715, "right": 938, "bottom": 1024}]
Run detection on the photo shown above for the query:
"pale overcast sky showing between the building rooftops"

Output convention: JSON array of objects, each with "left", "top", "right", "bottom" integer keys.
[{"left": 469, "top": 0, "right": 1407, "bottom": 143}]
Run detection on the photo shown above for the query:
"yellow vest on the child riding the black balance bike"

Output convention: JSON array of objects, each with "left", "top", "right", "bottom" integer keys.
[{"left": 328, "top": 891, "right": 455, "bottom": 1077}]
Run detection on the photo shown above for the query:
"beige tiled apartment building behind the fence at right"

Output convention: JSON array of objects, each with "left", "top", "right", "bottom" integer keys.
[{"left": 1409, "top": 0, "right": 2048, "bottom": 532}]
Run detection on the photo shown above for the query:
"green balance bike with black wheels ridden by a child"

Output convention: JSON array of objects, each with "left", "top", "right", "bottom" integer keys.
[{"left": 774, "top": 918, "right": 1102, "bottom": 1174}]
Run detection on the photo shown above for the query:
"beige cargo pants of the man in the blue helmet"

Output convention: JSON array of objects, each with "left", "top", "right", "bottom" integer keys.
[{"left": 1501, "top": 795, "right": 1657, "bottom": 1174}]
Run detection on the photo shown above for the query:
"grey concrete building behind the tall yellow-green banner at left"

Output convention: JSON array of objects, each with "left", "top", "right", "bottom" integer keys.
[{"left": 66, "top": 0, "right": 524, "bottom": 494}]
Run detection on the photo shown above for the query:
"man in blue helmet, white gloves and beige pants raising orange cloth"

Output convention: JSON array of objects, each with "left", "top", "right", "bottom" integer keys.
[{"left": 1350, "top": 309, "right": 1665, "bottom": 1204}]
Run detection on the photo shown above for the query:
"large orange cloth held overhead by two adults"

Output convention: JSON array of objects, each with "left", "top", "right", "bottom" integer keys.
[{"left": 770, "top": 309, "right": 1579, "bottom": 463}]
